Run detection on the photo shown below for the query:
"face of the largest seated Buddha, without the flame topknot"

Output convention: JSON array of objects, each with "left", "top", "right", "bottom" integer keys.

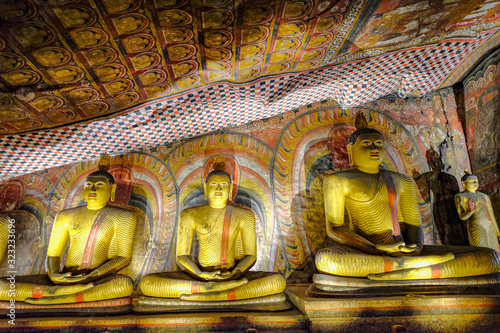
[{"left": 347, "top": 133, "right": 384, "bottom": 172}]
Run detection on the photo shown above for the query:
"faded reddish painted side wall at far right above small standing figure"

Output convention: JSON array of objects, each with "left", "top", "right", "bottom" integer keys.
[{"left": 463, "top": 51, "right": 500, "bottom": 221}]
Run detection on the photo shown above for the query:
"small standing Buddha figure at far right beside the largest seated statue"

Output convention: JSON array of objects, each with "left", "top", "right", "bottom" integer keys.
[{"left": 455, "top": 172, "right": 500, "bottom": 252}]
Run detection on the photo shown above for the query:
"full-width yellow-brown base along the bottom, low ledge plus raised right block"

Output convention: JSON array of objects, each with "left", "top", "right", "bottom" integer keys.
[{"left": 0, "top": 285, "right": 500, "bottom": 333}]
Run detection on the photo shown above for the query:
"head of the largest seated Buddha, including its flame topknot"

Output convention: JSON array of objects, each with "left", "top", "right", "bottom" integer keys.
[{"left": 347, "top": 112, "right": 384, "bottom": 173}]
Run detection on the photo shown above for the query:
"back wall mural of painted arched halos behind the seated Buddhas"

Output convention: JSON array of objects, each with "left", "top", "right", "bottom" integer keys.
[{"left": 0, "top": 90, "right": 467, "bottom": 286}]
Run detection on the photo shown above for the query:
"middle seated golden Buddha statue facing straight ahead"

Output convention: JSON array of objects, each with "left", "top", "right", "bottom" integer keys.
[{"left": 140, "top": 155, "right": 286, "bottom": 301}]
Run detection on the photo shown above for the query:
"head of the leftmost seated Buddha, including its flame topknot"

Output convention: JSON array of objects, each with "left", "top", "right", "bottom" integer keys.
[{"left": 83, "top": 153, "right": 116, "bottom": 210}]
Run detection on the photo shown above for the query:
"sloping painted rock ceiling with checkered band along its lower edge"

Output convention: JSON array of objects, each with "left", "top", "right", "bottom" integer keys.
[{"left": 0, "top": 0, "right": 500, "bottom": 176}]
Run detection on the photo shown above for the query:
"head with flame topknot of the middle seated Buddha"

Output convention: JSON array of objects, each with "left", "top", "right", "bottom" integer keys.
[{"left": 203, "top": 154, "right": 233, "bottom": 208}]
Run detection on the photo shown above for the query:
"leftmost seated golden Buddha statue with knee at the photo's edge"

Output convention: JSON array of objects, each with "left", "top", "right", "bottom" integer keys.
[{"left": 0, "top": 154, "right": 136, "bottom": 304}]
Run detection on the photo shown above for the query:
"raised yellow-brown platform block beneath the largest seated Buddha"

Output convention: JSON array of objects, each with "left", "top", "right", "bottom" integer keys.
[{"left": 286, "top": 285, "right": 500, "bottom": 333}]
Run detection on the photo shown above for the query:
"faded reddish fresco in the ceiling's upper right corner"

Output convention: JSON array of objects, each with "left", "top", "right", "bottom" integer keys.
[{"left": 346, "top": 0, "right": 500, "bottom": 53}]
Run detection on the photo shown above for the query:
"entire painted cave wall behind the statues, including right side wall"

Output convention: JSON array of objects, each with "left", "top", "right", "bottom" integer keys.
[{"left": 0, "top": 54, "right": 500, "bottom": 287}]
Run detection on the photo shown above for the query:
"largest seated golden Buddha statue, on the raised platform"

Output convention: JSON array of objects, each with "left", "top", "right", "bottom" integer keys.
[{"left": 315, "top": 112, "right": 500, "bottom": 283}]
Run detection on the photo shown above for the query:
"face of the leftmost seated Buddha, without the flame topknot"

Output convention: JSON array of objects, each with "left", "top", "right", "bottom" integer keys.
[{"left": 83, "top": 176, "right": 116, "bottom": 210}]
